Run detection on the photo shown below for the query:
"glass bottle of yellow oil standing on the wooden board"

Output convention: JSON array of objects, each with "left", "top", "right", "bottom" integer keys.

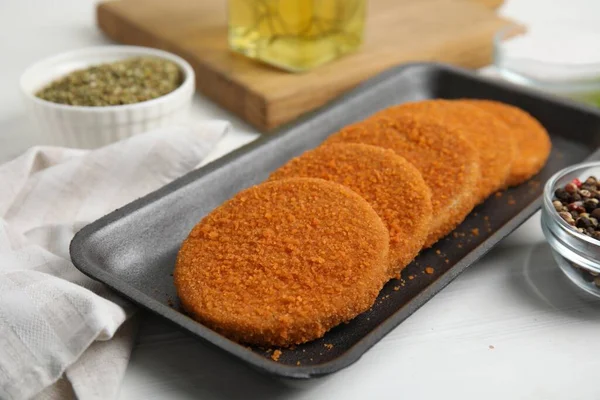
[{"left": 229, "top": 0, "right": 366, "bottom": 72}]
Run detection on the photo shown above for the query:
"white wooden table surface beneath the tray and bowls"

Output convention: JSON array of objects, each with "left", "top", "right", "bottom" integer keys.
[{"left": 0, "top": 0, "right": 600, "bottom": 400}]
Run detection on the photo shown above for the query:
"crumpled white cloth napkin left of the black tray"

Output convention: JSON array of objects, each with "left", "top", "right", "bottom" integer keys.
[{"left": 0, "top": 121, "right": 229, "bottom": 400}]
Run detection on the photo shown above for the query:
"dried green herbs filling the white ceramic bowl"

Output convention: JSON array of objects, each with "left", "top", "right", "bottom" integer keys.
[{"left": 36, "top": 57, "right": 183, "bottom": 107}]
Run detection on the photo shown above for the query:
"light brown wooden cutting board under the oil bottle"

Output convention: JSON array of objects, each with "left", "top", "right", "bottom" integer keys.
[{"left": 97, "top": 0, "right": 510, "bottom": 131}]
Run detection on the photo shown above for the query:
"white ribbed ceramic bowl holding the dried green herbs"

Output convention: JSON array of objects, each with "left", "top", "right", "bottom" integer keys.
[{"left": 21, "top": 46, "right": 195, "bottom": 149}]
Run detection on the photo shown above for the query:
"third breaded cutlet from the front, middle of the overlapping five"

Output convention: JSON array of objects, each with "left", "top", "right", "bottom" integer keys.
[{"left": 325, "top": 115, "right": 480, "bottom": 247}]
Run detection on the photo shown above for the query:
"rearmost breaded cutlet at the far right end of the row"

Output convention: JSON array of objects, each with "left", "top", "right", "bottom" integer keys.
[{"left": 460, "top": 99, "right": 552, "bottom": 186}]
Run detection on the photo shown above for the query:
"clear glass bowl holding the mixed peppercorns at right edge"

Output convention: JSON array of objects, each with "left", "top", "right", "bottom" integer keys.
[{"left": 541, "top": 161, "right": 600, "bottom": 297}]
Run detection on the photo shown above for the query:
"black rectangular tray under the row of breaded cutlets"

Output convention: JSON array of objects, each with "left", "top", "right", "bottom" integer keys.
[{"left": 71, "top": 63, "right": 600, "bottom": 378}]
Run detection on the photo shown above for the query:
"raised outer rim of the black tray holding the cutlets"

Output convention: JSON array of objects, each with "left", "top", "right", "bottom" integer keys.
[{"left": 69, "top": 62, "right": 600, "bottom": 379}]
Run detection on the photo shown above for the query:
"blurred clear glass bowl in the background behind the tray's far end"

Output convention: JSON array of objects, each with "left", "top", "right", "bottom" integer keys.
[{"left": 494, "top": 23, "right": 600, "bottom": 106}]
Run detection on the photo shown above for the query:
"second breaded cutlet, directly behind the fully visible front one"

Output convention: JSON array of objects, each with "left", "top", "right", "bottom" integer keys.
[{"left": 269, "top": 143, "right": 432, "bottom": 279}]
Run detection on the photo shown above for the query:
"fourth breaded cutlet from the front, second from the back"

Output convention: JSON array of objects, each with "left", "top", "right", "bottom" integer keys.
[{"left": 380, "top": 100, "right": 517, "bottom": 201}]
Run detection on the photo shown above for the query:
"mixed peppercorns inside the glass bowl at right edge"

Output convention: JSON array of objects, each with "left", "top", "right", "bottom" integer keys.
[{"left": 552, "top": 176, "right": 600, "bottom": 240}]
